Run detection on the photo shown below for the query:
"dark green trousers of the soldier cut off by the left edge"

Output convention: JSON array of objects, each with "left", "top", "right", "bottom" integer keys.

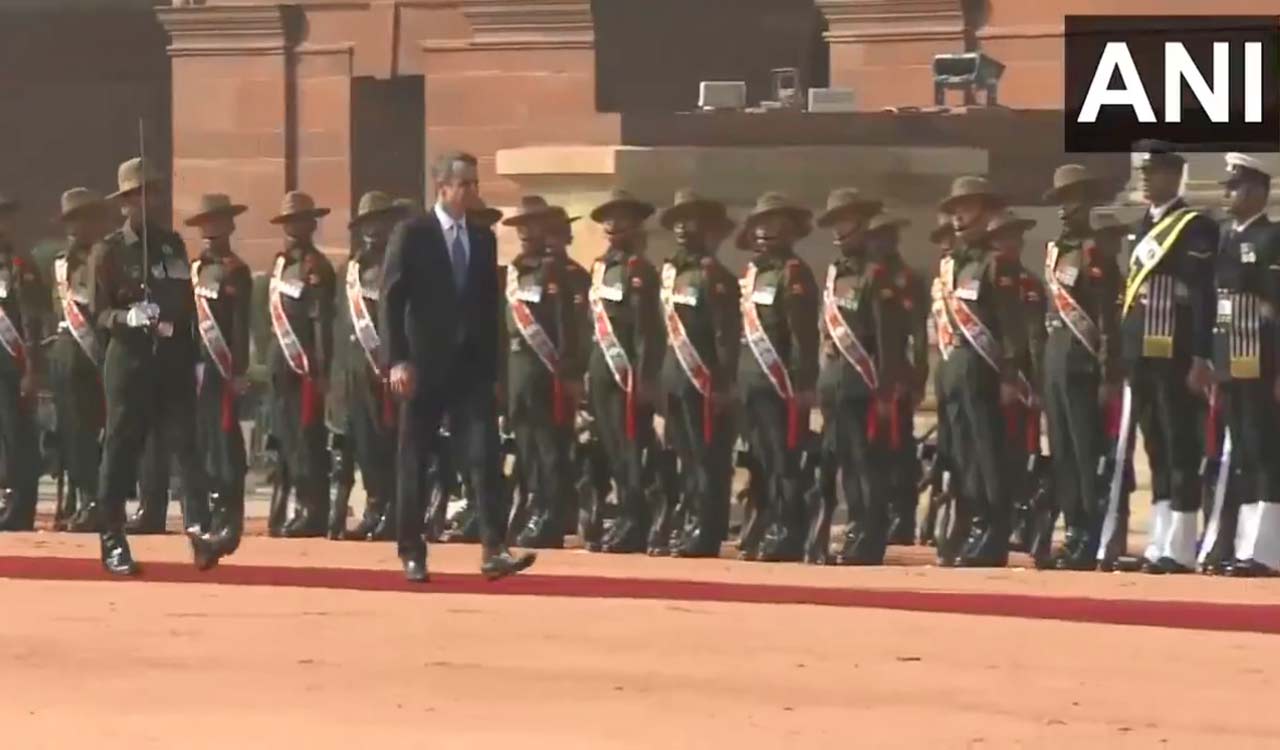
[{"left": 0, "top": 370, "right": 40, "bottom": 530}]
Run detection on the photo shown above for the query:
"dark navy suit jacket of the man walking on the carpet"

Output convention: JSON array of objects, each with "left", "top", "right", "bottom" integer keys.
[{"left": 378, "top": 211, "right": 499, "bottom": 401}]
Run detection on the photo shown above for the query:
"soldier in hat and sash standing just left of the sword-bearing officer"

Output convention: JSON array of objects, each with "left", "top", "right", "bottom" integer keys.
[{"left": 47, "top": 188, "right": 108, "bottom": 532}]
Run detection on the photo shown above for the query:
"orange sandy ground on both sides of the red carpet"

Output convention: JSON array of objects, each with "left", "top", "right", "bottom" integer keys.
[{"left": 0, "top": 534, "right": 1280, "bottom": 750}]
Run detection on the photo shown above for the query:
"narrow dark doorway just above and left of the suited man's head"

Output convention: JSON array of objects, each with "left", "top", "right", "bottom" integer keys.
[{"left": 351, "top": 76, "right": 426, "bottom": 214}]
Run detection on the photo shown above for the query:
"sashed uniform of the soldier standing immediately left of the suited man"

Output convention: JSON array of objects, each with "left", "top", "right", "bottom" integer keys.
[{"left": 329, "top": 251, "right": 398, "bottom": 539}]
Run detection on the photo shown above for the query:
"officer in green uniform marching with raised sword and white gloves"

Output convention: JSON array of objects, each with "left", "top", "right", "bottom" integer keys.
[{"left": 88, "top": 159, "right": 209, "bottom": 568}]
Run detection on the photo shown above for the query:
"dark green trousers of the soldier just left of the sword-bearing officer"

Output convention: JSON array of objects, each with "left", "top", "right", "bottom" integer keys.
[{"left": 49, "top": 333, "right": 105, "bottom": 506}]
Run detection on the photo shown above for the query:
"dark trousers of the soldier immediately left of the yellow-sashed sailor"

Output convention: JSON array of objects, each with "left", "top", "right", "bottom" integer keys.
[{"left": 1044, "top": 329, "right": 1106, "bottom": 543}]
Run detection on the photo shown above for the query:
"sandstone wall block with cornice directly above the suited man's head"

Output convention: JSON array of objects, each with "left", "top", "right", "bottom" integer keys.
[{"left": 420, "top": 0, "right": 621, "bottom": 205}]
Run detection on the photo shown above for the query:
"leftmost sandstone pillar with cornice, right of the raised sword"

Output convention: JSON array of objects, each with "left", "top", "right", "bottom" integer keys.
[{"left": 156, "top": 5, "right": 289, "bottom": 267}]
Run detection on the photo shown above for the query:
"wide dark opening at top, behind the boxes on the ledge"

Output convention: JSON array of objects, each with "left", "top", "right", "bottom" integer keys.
[{"left": 593, "top": 0, "right": 829, "bottom": 113}]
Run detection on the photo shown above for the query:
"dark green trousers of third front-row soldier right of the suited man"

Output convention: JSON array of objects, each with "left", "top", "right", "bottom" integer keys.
[{"left": 663, "top": 381, "right": 735, "bottom": 554}]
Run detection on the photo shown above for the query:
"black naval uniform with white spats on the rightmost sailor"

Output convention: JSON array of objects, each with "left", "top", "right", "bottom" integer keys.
[{"left": 1206, "top": 215, "right": 1280, "bottom": 572}]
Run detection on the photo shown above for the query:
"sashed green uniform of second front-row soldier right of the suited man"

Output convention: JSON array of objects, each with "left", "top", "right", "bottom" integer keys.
[{"left": 588, "top": 250, "right": 666, "bottom": 553}]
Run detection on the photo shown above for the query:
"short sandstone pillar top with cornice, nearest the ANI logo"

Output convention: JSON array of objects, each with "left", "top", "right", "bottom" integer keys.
[{"left": 815, "top": 0, "right": 965, "bottom": 110}]
